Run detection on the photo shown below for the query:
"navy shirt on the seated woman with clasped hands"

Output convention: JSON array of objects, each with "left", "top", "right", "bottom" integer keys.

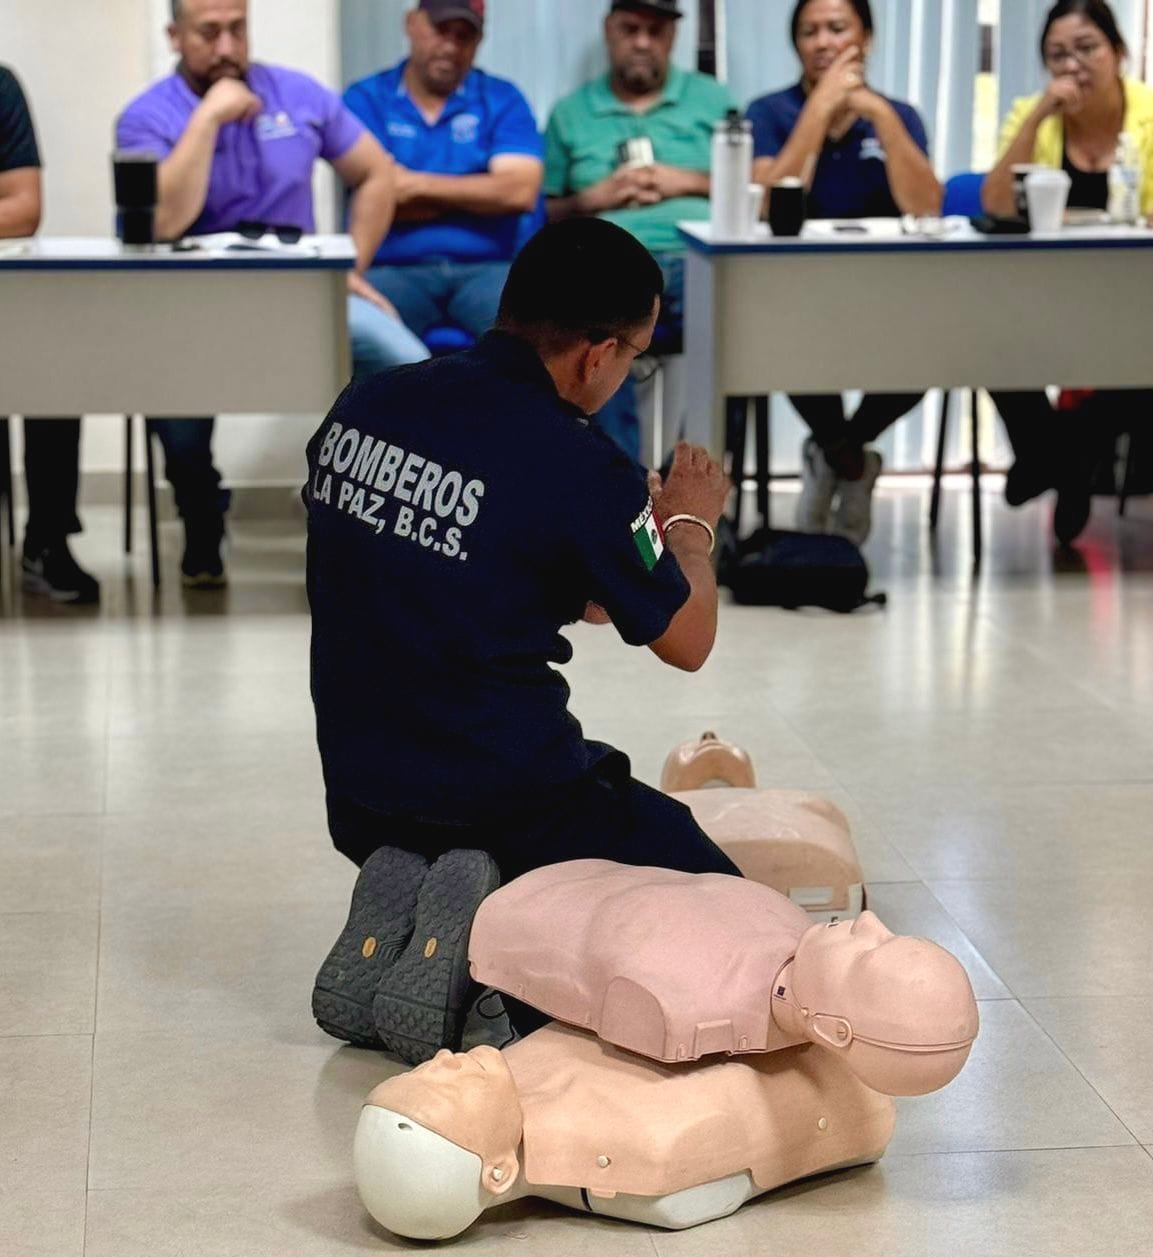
[{"left": 747, "top": 83, "right": 929, "bottom": 219}]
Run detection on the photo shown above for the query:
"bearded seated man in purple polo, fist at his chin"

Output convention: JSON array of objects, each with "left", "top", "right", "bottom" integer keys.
[{"left": 116, "top": 0, "right": 428, "bottom": 588}]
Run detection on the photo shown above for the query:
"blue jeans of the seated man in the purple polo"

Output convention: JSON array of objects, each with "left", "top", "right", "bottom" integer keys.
[{"left": 152, "top": 295, "right": 429, "bottom": 530}]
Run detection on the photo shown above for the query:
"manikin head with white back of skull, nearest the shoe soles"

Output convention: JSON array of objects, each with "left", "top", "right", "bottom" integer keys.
[{"left": 355, "top": 1047, "right": 523, "bottom": 1239}]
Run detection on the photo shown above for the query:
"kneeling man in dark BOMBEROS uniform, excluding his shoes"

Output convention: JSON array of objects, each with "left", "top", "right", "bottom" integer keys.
[{"left": 304, "top": 219, "right": 737, "bottom": 1037}]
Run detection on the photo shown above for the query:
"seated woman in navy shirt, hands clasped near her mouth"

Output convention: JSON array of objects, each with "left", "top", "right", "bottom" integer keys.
[{"left": 748, "top": 0, "right": 943, "bottom": 544}]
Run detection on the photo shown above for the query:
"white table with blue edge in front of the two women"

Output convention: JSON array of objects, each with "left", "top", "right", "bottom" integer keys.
[{"left": 680, "top": 224, "right": 1153, "bottom": 450}]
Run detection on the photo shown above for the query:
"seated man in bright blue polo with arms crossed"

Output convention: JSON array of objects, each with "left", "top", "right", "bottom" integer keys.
[{"left": 345, "top": 0, "right": 543, "bottom": 337}]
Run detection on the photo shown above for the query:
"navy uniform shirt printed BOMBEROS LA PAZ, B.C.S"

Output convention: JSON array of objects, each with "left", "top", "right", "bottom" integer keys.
[{"left": 304, "top": 332, "right": 689, "bottom": 823}]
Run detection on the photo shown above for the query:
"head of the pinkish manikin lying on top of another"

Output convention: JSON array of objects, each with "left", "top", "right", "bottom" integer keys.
[{"left": 775, "top": 913, "right": 978, "bottom": 1096}]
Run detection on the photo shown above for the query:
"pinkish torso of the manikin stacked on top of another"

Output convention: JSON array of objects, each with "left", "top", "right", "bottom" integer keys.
[{"left": 469, "top": 860, "right": 812, "bottom": 1061}]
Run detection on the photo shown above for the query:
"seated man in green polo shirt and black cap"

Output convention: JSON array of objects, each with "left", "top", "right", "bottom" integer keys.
[{"left": 544, "top": 0, "right": 736, "bottom": 459}]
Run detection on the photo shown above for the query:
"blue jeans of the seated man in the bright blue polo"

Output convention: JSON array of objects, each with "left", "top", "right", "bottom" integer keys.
[{"left": 365, "top": 261, "right": 509, "bottom": 338}]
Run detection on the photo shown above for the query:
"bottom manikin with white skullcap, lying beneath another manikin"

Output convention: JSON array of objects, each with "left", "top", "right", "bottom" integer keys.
[{"left": 355, "top": 1023, "right": 894, "bottom": 1239}]
